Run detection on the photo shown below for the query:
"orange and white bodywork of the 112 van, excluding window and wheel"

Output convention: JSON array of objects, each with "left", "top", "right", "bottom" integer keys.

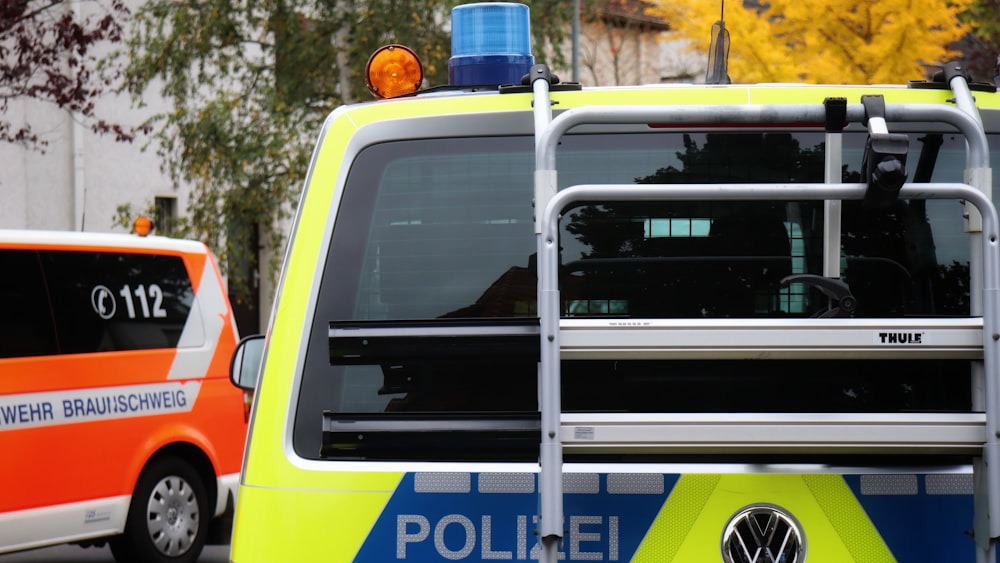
[{"left": 0, "top": 233, "right": 247, "bottom": 553}]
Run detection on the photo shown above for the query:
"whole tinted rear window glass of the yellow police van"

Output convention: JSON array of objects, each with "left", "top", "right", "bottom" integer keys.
[{"left": 293, "top": 131, "right": 970, "bottom": 459}]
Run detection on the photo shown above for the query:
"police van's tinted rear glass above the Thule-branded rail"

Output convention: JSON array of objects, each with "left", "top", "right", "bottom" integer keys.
[{"left": 324, "top": 132, "right": 970, "bottom": 320}]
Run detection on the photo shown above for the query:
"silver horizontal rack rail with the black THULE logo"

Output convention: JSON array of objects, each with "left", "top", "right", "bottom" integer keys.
[{"left": 559, "top": 318, "right": 983, "bottom": 360}]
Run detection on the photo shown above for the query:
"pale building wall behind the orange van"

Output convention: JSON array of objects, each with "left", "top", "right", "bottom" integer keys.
[{"left": 0, "top": 0, "right": 190, "bottom": 236}]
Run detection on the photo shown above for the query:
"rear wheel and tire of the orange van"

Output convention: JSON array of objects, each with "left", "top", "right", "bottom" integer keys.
[{"left": 110, "top": 457, "right": 211, "bottom": 563}]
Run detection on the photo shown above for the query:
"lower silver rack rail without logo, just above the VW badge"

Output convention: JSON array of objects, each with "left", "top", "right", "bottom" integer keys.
[{"left": 562, "top": 413, "right": 986, "bottom": 455}]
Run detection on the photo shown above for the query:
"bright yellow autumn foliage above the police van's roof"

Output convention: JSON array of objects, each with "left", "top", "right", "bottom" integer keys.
[{"left": 648, "top": 0, "right": 973, "bottom": 84}]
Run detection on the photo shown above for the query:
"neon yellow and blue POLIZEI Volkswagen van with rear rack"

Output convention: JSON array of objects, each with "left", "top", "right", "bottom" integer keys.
[{"left": 231, "top": 3, "right": 1000, "bottom": 563}]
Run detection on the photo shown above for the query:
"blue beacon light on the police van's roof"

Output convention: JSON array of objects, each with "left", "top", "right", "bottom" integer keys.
[{"left": 448, "top": 2, "right": 535, "bottom": 86}]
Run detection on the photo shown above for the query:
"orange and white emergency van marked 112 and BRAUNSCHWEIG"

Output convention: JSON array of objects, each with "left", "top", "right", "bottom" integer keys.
[{"left": 0, "top": 230, "right": 247, "bottom": 563}]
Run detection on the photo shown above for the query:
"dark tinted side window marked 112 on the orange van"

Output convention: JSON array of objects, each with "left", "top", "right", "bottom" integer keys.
[{"left": 0, "top": 249, "right": 194, "bottom": 358}]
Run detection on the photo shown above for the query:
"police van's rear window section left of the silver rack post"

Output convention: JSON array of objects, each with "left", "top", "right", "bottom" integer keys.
[{"left": 294, "top": 138, "right": 537, "bottom": 457}]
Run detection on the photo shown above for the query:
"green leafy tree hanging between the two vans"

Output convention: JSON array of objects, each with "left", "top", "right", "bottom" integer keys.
[{"left": 126, "top": 0, "right": 572, "bottom": 296}]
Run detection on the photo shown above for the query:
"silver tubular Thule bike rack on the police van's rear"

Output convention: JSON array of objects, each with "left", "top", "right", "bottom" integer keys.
[{"left": 527, "top": 65, "right": 1000, "bottom": 563}]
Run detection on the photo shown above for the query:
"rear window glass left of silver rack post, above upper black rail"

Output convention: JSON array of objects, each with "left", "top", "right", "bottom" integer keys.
[{"left": 344, "top": 139, "right": 536, "bottom": 319}]
